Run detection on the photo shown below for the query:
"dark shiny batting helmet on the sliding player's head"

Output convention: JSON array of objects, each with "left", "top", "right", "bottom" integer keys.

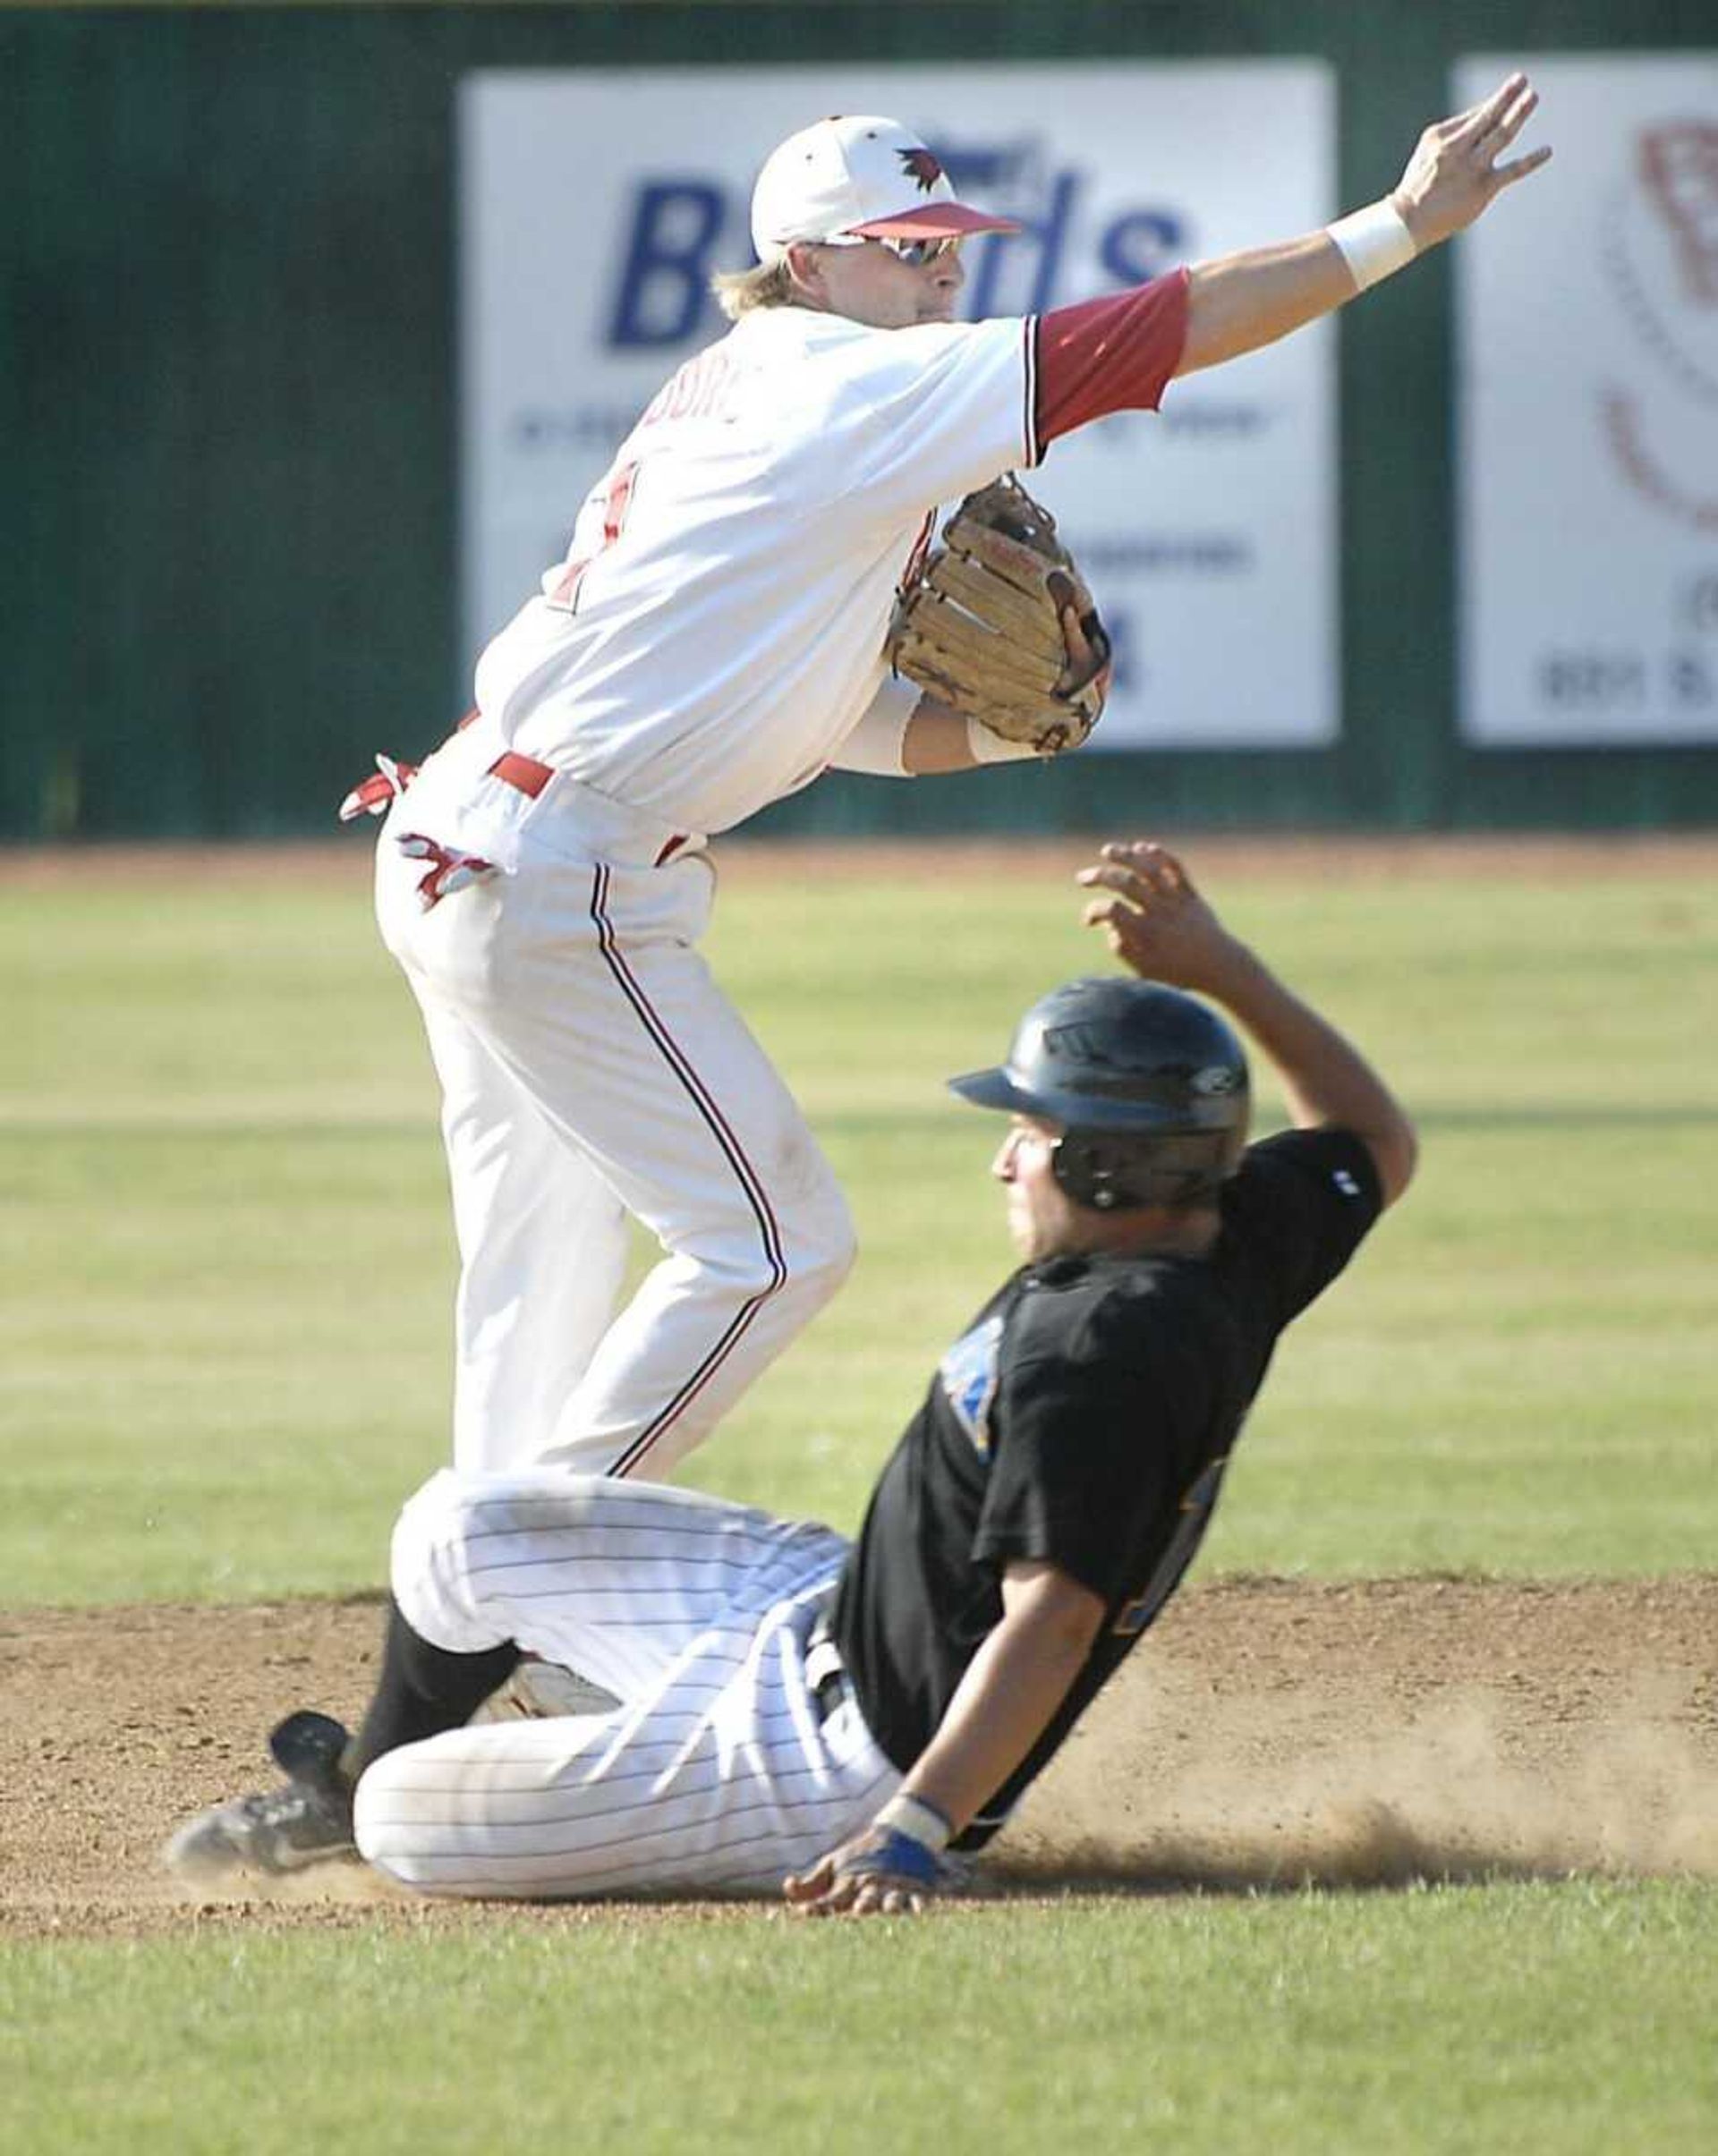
[{"left": 948, "top": 974, "right": 1250, "bottom": 1211}]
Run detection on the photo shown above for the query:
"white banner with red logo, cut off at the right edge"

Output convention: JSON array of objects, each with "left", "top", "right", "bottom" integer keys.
[{"left": 1455, "top": 52, "right": 1718, "bottom": 746}]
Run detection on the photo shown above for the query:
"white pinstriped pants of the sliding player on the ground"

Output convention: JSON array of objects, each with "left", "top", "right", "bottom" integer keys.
[{"left": 355, "top": 1468, "right": 901, "bottom": 1899}]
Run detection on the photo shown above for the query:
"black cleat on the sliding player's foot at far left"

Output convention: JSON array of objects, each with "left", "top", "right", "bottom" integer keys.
[{"left": 162, "top": 1710, "right": 355, "bottom": 1887}]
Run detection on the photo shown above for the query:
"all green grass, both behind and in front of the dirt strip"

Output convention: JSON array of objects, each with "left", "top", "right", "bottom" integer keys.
[{"left": 0, "top": 847, "right": 1718, "bottom": 2156}]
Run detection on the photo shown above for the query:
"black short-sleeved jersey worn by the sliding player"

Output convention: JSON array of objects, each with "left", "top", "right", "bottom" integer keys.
[{"left": 829, "top": 1130, "right": 1380, "bottom": 1847}]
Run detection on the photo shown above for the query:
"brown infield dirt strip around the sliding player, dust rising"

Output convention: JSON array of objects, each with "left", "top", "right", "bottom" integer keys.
[{"left": 0, "top": 1576, "right": 1718, "bottom": 1936}]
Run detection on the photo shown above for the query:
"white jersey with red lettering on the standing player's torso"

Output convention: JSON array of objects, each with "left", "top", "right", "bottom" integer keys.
[{"left": 476, "top": 309, "right": 1037, "bottom": 832}]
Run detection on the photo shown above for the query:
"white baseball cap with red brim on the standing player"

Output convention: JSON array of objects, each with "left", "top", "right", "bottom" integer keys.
[{"left": 753, "top": 115, "right": 1019, "bottom": 263}]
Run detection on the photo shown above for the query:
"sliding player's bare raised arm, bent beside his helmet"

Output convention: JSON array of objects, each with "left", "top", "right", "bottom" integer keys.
[{"left": 1078, "top": 841, "right": 1418, "bottom": 1205}]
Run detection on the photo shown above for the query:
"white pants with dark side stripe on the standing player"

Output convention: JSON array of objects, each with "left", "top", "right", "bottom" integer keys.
[{"left": 378, "top": 726, "right": 854, "bottom": 1477}]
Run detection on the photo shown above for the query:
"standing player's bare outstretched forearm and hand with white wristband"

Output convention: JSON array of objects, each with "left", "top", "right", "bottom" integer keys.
[{"left": 1175, "top": 73, "right": 1550, "bottom": 375}]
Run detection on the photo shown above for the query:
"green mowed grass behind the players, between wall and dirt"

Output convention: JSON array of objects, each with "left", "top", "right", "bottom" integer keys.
[{"left": 0, "top": 850, "right": 1718, "bottom": 1604}]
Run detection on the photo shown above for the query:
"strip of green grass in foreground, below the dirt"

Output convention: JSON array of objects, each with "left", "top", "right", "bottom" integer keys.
[{"left": 0, "top": 1884, "right": 1718, "bottom": 2156}]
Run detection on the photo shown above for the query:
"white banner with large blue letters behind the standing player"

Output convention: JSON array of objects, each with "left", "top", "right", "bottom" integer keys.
[{"left": 459, "top": 60, "right": 1339, "bottom": 748}]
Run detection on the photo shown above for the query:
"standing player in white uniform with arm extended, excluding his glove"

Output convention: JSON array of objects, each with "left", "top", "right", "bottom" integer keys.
[{"left": 362, "top": 88, "right": 1548, "bottom": 1477}]
